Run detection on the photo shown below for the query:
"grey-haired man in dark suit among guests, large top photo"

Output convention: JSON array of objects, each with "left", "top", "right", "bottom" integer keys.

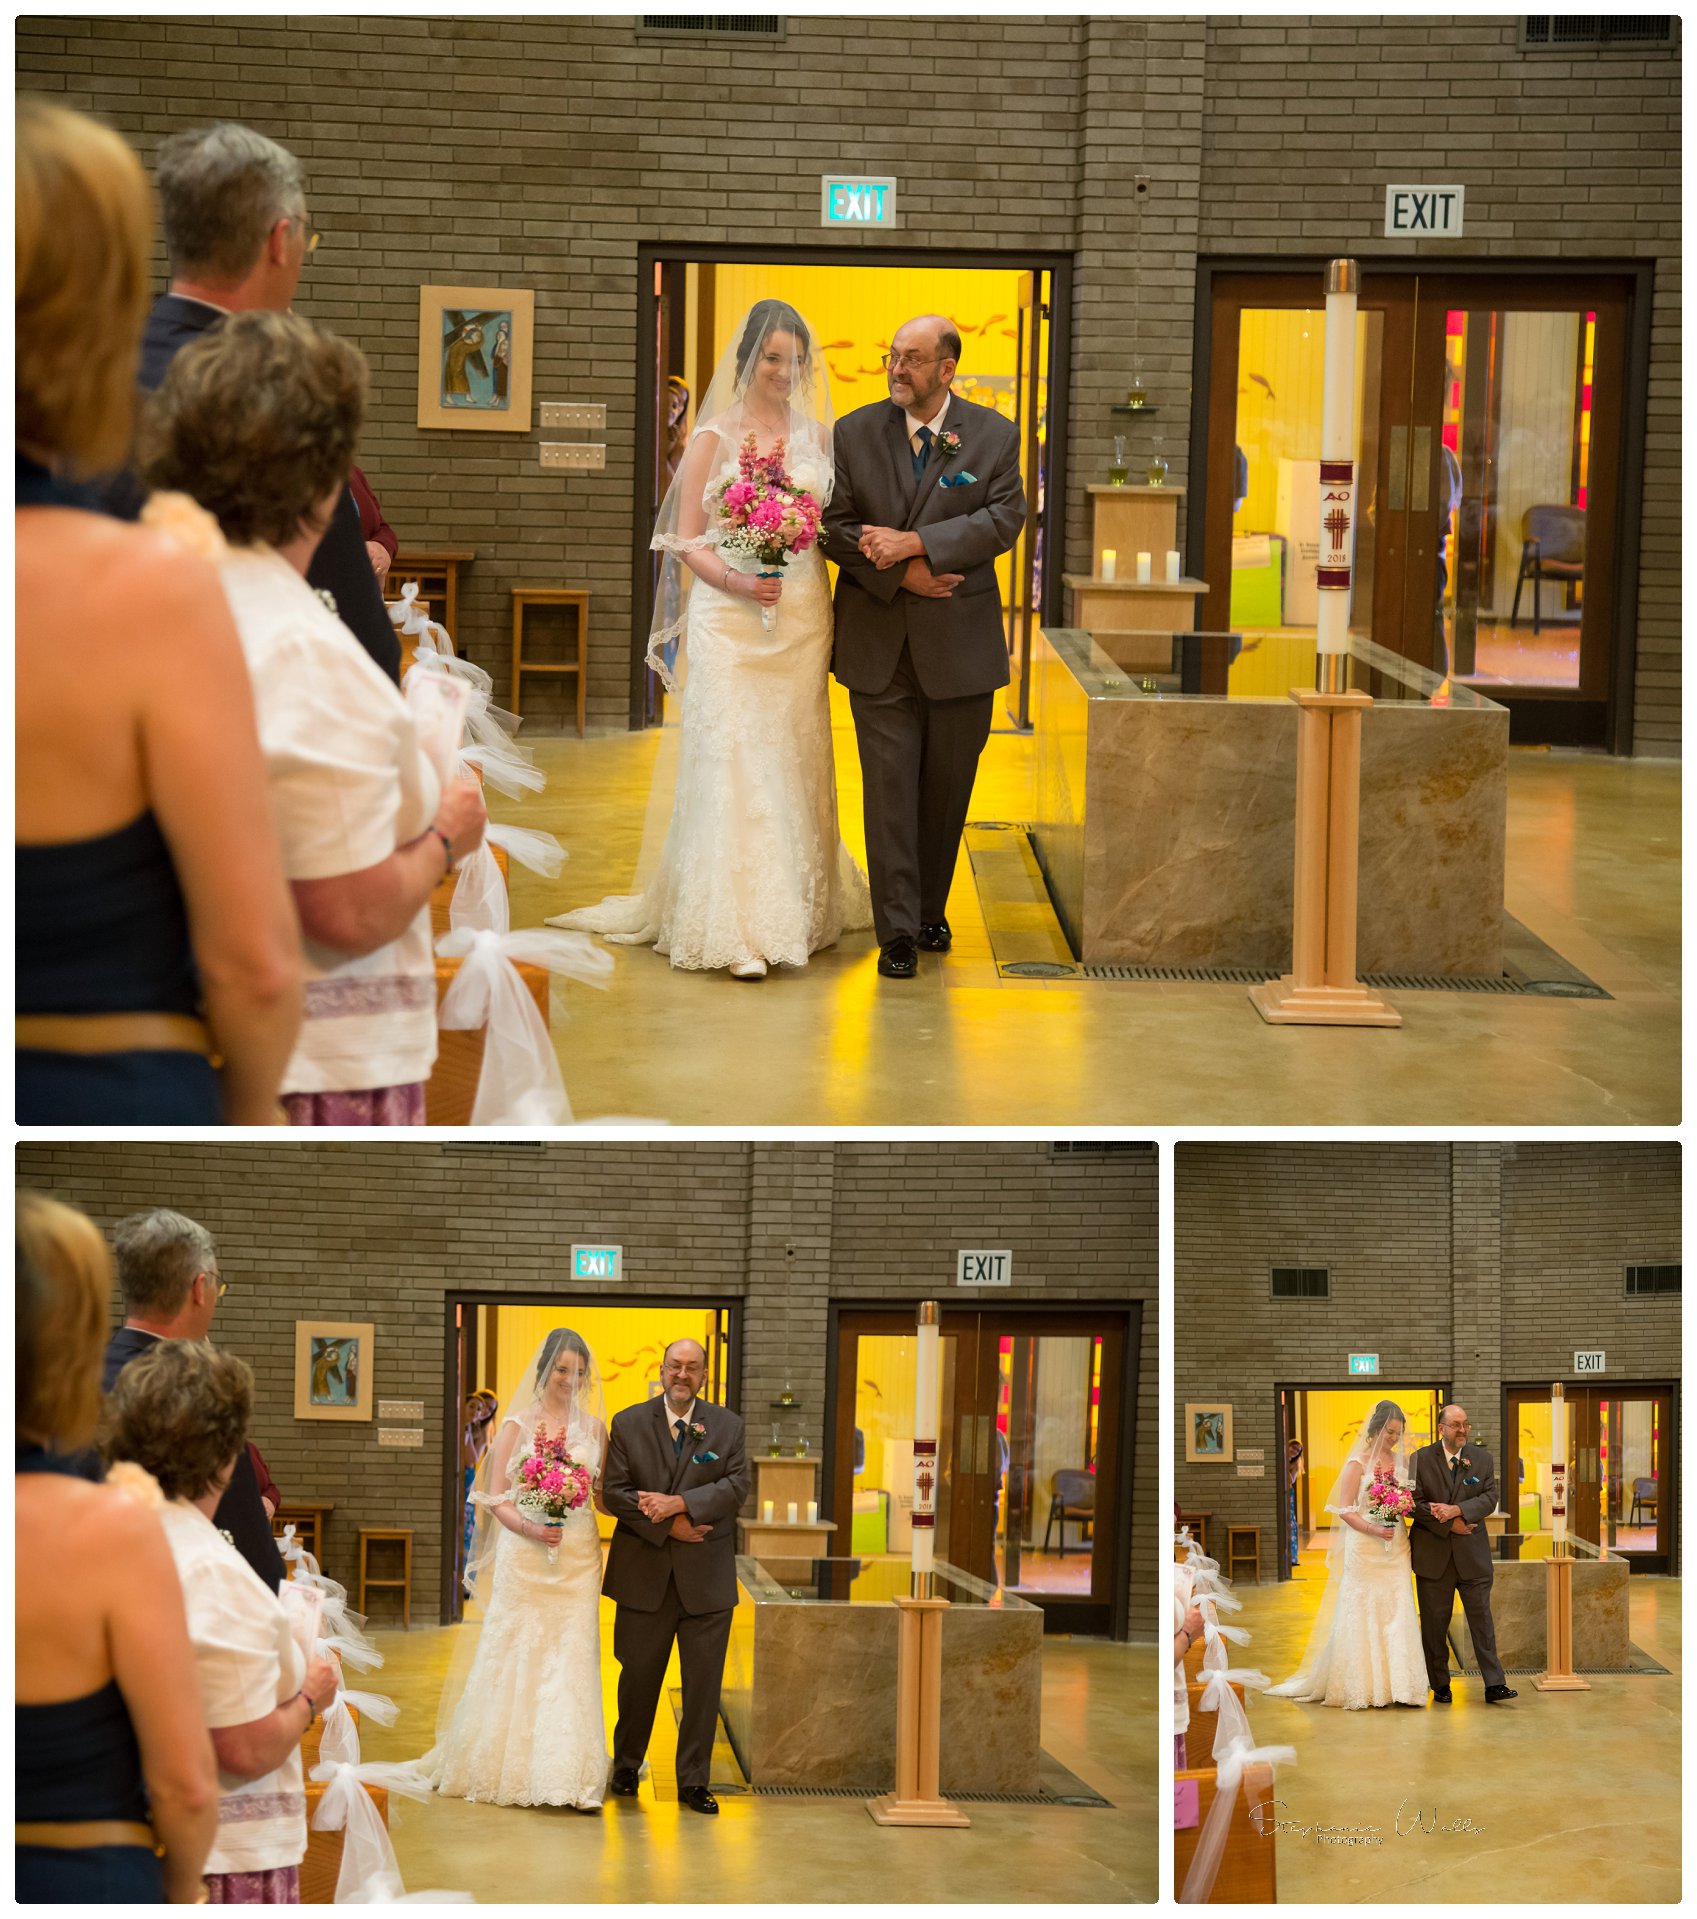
[{"left": 136, "top": 123, "right": 401, "bottom": 683}]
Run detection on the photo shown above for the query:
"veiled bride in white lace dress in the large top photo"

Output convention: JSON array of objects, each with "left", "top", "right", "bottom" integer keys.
[{"left": 547, "top": 310, "right": 872, "bottom": 979}]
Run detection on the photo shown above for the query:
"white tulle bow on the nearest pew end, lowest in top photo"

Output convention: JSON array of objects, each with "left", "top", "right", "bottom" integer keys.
[{"left": 436, "top": 927, "right": 612, "bottom": 1126}]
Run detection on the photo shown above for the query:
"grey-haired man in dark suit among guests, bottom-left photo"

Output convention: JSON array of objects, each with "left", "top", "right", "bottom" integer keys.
[{"left": 100, "top": 1207, "right": 282, "bottom": 1593}]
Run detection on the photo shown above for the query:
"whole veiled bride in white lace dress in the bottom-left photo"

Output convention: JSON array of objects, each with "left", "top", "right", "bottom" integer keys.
[{"left": 417, "top": 1326, "right": 609, "bottom": 1812}]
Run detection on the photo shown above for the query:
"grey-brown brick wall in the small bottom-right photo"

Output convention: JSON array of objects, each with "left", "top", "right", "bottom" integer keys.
[{"left": 1173, "top": 1142, "right": 1680, "bottom": 1579}]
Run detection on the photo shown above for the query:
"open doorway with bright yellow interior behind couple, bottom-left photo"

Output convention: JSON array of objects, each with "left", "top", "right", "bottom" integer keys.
[{"left": 442, "top": 1293, "right": 741, "bottom": 1623}]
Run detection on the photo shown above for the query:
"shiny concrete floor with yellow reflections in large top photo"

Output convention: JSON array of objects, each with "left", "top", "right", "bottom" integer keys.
[{"left": 493, "top": 689, "right": 1680, "bottom": 1126}]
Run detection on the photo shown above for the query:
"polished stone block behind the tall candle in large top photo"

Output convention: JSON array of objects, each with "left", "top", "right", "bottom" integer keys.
[{"left": 1031, "top": 629, "right": 1509, "bottom": 979}]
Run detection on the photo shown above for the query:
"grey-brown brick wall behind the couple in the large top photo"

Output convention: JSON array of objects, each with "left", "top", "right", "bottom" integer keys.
[{"left": 17, "top": 15, "right": 1682, "bottom": 752}]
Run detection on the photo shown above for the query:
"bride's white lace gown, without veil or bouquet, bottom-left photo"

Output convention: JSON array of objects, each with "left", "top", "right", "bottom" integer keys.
[{"left": 418, "top": 1420, "right": 609, "bottom": 1808}]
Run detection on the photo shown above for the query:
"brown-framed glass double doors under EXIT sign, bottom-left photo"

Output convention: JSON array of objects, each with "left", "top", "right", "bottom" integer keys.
[{"left": 831, "top": 1309, "right": 1131, "bottom": 1633}]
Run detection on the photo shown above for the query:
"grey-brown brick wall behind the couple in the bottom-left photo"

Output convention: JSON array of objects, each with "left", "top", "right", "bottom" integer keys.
[{"left": 17, "top": 1142, "right": 1158, "bottom": 1639}]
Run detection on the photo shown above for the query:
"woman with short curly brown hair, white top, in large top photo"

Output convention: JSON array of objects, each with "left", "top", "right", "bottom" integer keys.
[{"left": 140, "top": 313, "right": 488, "bottom": 1126}]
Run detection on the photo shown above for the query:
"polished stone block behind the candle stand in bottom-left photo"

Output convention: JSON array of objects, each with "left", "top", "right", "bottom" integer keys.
[{"left": 724, "top": 1556, "right": 1042, "bottom": 1794}]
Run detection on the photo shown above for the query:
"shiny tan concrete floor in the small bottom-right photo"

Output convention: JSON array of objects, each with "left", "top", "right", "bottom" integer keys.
[{"left": 1205, "top": 1554, "right": 1682, "bottom": 1906}]
